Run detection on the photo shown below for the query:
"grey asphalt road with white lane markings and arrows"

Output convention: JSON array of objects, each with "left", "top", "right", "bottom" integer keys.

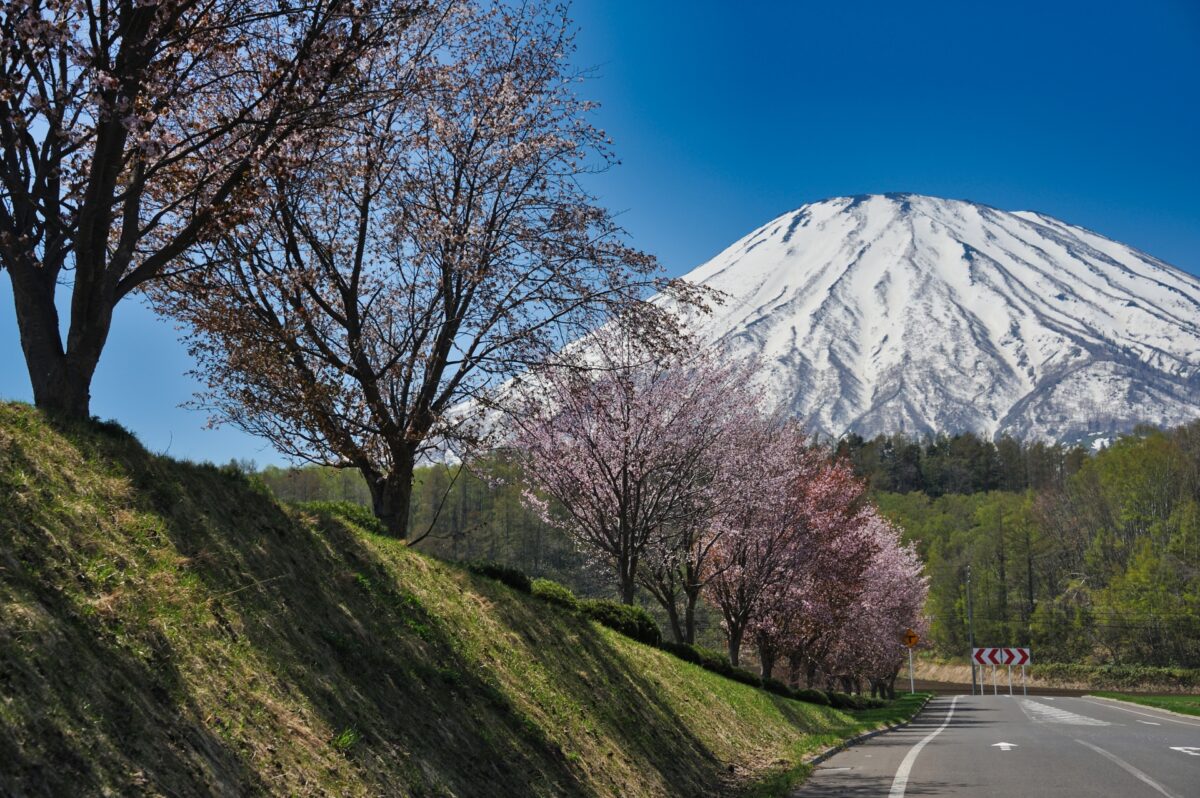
[{"left": 793, "top": 695, "right": 1200, "bottom": 798}]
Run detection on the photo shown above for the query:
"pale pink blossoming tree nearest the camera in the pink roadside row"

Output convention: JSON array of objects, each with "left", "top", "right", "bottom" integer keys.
[{"left": 511, "top": 323, "right": 754, "bottom": 604}]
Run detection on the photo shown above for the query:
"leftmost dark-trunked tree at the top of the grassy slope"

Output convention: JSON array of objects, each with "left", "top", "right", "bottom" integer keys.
[{"left": 0, "top": 0, "right": 417, "bottom": 418}]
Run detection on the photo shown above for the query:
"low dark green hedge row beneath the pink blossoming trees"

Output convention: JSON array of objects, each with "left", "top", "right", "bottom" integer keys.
[{"left": 467, "top": 563, "right": 886, "bottom": 709}]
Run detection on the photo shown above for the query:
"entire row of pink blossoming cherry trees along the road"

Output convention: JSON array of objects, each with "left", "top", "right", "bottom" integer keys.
[{"left": 511, "top": 324, "right": 926, "bottom": 686}]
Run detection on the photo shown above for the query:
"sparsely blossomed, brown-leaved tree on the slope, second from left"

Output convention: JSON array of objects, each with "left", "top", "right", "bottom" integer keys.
[{"left": 164, "top": 2, "right": 686, "bottom": 536}]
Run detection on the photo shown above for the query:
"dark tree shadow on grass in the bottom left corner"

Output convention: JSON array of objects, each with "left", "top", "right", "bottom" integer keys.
[{"left": 0, "top": 432, "right": 270, "bottom": 797}]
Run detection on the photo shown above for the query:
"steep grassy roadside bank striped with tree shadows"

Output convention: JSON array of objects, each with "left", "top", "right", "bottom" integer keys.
[{"left": 0, "top": 403, "right": 912, "bottom": 796}]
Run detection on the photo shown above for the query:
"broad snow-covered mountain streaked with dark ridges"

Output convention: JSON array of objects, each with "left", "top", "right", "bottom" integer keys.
[{"left": 684, "top": 194, "right": 1200, "bottom": 440}]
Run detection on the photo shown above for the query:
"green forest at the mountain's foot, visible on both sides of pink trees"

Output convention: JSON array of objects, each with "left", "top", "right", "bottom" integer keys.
[{"left": 255, "top": 422, "right": 1200, "bottom": 667}]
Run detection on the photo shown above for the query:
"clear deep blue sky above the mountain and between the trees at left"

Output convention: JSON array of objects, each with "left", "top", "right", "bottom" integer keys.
[{"left": 0, "top": 0, "right": 1200, "bottom": 463}]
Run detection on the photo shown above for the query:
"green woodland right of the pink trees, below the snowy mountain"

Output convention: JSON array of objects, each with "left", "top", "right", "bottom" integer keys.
[{"left": 873, "top": 422, "right": 1200, "bottom": 667}]
